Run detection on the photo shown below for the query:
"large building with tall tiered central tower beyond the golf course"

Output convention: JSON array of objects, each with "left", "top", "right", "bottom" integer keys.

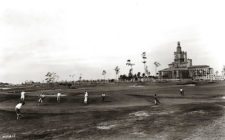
[{"left": 159, "top": 42, "right": 213, "bottom": 79}]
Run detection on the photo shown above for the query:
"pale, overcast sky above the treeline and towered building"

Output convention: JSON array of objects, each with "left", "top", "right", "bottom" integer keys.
[{"left": 0, "top": 0, "right": 225, "bottom": 83}]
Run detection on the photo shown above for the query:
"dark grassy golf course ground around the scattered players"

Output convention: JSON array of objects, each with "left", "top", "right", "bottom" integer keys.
[{"left": 0, "top": 83, "right": 225, "bottom": 140}]
